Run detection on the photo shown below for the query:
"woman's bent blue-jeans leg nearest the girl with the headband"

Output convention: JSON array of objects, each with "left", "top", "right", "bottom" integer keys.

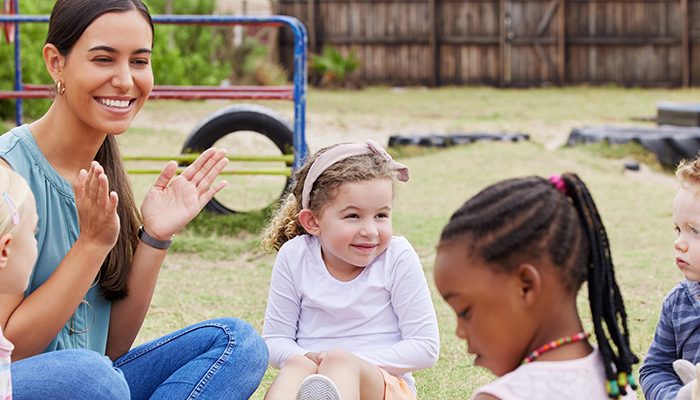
[{"left": 114, "top": 318, "right": 268, "bottom": 400}]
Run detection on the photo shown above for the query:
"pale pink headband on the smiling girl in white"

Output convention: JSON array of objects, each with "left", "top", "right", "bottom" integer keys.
[{"left": 301, "top": 140, "right": 408, "bottom": 208}]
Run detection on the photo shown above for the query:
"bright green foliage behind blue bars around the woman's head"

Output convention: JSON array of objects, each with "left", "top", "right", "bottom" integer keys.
[{"left": 0, "top": 0, "right": 231, "bottom": 119}]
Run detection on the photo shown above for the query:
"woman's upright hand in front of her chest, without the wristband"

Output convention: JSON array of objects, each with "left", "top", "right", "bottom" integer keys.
[{"left": 73, "top": 161, "right": 119, "bottom": 250}]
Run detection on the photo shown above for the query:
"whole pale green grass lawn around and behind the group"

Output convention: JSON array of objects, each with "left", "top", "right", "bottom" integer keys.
[{"left": 6, "top": 87, "right": 700, "bottom": 399}]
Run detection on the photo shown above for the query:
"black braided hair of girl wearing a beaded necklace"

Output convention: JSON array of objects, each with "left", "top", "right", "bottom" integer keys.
[{"left": 440, "top": 173, "right": 639, "bottom": 399}]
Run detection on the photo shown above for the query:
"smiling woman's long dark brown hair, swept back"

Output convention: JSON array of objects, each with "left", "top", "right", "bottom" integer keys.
[{"left": 46, "top": 0, "right": 153, "bottom": 300}]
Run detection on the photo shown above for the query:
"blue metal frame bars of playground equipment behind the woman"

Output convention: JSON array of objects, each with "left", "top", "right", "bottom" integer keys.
[{"left": 0, "top": 12, "right": 308, "bottom": 169}]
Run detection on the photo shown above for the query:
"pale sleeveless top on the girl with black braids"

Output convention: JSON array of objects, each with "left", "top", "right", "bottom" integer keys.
[{"left": 472, "top": 347, "right": 637, "bottom": 400}]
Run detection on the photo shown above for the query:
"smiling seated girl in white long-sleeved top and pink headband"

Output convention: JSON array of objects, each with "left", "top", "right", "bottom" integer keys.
[{"left": 263, "top": 141, "right": 439, "bottom": 400}]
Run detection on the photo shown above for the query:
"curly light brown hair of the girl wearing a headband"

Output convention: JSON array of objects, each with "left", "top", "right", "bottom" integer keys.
[{"left": 260, "top": 145, "right": 395, "bottom": 251}]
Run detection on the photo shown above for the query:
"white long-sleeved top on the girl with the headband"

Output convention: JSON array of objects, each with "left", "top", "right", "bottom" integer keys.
[{"left": 263, "top": 235, "right": 440, "bottom": 392}]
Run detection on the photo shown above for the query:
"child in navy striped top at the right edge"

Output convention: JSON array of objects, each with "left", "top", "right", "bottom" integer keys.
[{"left": 640, "top": 159, "right": 700, "bottom": 400}]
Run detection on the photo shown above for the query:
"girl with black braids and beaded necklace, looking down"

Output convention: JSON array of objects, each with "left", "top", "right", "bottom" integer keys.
[{"left": 435, "top": 174, "right": 638, "bottom": 400}]
